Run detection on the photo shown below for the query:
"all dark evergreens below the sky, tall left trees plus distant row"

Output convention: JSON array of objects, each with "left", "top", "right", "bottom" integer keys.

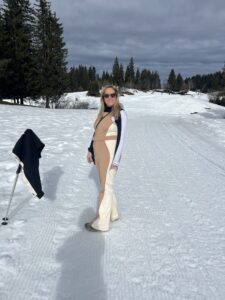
[{"left": 0, "top": 0, "right": 225, "bottom": 107}]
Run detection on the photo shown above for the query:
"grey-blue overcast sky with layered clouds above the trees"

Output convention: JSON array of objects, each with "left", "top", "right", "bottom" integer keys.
[{"left": 0, "top": 0, "right": 225, "bottom": 79}]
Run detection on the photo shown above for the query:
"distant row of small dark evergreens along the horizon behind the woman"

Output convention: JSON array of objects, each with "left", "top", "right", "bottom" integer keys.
[{"left": 62, "top": 61, "right": 225, "bottom": 95}]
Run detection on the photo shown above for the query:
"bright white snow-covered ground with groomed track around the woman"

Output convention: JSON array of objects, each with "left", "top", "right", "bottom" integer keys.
[{"left": 0, "top": 92, "right": 225, "bottom": 300}]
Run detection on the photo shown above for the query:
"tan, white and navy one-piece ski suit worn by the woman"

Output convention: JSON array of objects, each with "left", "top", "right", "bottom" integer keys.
[{"left": 88, "top": 108, "right": 127, "bottom": 231}]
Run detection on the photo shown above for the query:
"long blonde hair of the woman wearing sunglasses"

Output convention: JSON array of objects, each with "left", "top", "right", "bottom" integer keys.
[{"left": 94, "top": 85, "right": 122, "bottom": 127}]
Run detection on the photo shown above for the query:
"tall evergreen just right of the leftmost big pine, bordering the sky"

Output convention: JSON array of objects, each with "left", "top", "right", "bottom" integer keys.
[{"left": 35, "top": 0, "right": 67, "bottom": 108}]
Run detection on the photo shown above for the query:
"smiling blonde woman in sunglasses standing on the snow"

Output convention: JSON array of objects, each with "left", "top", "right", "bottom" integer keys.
[{"left": 85, "top": 85, "right": 127, "bottom": 231}]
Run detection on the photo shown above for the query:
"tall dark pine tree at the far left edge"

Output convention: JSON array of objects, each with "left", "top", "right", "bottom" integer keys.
[{"left": 2, "top": 0, "right": 34, "bottom": 104}]
